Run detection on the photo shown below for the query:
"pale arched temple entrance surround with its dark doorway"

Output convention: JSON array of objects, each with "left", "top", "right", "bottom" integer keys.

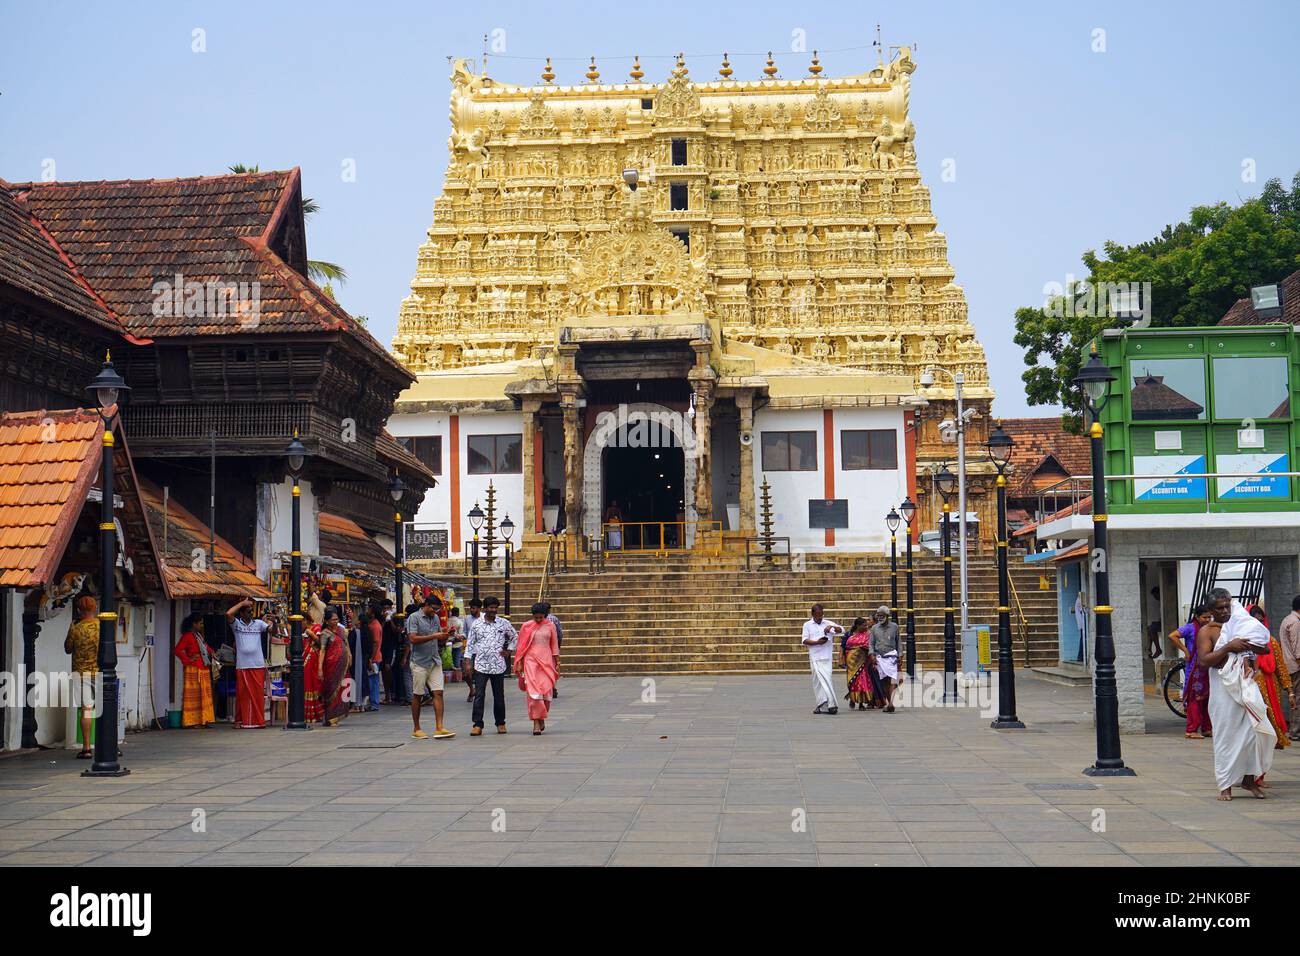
[{"left": 582, "top": 402, "right": 696, "bottom": 546}]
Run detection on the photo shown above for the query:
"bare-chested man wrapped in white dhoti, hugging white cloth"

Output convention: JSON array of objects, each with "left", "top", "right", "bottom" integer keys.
[{"left": 1196, "top": 588, "right": 1277, "bottom": 800}]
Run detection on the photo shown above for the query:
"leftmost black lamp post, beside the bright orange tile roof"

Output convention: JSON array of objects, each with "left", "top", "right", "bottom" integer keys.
[{"left": 82, "top": 352, "right": 131, "bottom": 777}]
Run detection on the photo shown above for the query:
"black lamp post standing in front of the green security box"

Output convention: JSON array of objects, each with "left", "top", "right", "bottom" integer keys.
[{"left": 1074, "top": 350, "right": 1134, "bottom": 777}]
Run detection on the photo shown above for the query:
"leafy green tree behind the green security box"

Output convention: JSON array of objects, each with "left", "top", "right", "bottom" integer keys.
[{"left": 1015, "top": 173, "right": 1300, "bottom": 408}]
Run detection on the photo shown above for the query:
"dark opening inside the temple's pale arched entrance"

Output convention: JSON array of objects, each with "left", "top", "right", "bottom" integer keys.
[{"left": 603, "top": 447, "right": 686, "bottom": 549}]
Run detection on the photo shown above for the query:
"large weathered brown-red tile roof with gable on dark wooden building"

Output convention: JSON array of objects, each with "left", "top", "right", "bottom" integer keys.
[{"left": 8, "top": 169, "right": 413, "bottom": 380}]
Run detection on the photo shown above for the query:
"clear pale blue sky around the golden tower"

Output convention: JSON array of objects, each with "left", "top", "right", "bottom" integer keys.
[{"left": 0, "top": 0, "right": 1300, "bottom": 415}]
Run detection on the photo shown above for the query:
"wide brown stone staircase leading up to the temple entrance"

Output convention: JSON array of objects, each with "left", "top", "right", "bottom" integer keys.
[{"left": 436, "top": 553, "right": 1058, "bottom": 675}]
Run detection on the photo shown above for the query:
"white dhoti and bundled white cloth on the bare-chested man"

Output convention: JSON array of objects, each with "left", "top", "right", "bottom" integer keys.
[{"left": 1209, "top": 601, "right": 1278, "bottom": 791}]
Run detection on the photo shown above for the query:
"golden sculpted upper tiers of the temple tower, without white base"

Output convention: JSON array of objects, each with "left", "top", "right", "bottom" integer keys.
[{"left": 393, "top": 48, "right": 991, "bottom": 398}]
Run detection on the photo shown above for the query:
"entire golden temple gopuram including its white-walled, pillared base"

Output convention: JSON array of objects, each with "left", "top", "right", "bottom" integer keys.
[{"left": 390, "top": 47, "right": 993, "bottom": 551}]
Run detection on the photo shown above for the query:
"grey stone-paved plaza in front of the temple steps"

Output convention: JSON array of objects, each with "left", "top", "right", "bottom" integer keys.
[{"left": 0, "top": 672, "right": 1300, "bottom": 866}]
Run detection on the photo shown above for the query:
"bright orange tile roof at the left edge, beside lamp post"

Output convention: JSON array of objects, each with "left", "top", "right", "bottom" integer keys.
[{"left": 0, "top": 408, "right": 103, "bottom": 588}]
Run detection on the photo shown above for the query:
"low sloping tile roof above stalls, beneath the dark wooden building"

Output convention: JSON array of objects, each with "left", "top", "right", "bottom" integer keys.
[{"left": 139, "top": 477, "right": 270, "bottom": 598}]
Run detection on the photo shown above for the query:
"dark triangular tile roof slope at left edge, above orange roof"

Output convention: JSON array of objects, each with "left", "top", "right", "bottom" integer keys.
[{"left": 0, "top": 187, "right": 122, "bottom": 333}]
